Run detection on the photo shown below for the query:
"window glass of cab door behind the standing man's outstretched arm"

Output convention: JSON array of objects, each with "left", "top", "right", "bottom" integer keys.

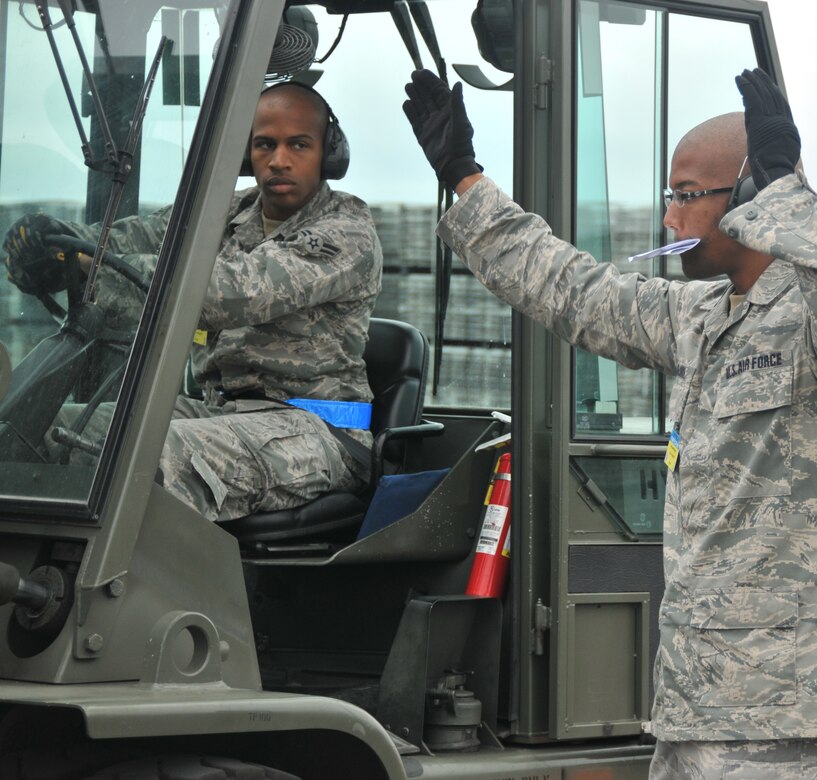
[{"left": 574, "top": 0, "right": 757, "bottom": 437}]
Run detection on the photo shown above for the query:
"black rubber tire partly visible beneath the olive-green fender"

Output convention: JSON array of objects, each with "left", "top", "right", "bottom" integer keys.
[{"left": 86, "top": 756, "right": 299, "bottom": 780}]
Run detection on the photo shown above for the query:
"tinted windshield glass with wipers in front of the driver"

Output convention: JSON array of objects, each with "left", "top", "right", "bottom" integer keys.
[{"left": 0, "top": 0, "right": 227, "bottom": 504}]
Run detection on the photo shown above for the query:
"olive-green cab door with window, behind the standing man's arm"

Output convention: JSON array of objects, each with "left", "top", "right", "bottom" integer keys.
[{"left": 507, "top": 0, "right": 782, "bottom": 742}]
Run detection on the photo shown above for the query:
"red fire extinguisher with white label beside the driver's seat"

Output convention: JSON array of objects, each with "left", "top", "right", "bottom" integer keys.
[{"left": 465, "top": 452, "right": 511, "bottom": 598}]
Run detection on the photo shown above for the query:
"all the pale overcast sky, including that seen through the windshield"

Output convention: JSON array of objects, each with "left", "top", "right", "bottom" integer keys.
[{"left": 0, "top": 0, "right": 817, "bottom": 203}]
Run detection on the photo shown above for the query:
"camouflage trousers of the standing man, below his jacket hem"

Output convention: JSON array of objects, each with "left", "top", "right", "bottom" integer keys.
[{"left": 649, "top": 739, "right": 817, "bottom": 780}]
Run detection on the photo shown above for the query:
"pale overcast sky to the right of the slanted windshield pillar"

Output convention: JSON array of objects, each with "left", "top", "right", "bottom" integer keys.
[{"left": 318, "top": 0, "right": 817, "bottom": 203}]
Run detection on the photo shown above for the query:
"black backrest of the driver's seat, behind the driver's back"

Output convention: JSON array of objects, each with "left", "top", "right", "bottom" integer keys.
[{"left": 363, "top": 317, "right": 428, "bottom": 462}]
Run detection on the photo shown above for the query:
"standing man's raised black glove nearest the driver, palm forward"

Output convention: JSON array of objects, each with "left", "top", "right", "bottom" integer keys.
[{"left": 403, "top": 70, "right": 482, "bottom": 189}]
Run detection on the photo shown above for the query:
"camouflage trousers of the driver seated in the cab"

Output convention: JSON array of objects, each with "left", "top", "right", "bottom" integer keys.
[{"left": 56, "top": 396, "right": 371, "bottom": 520}]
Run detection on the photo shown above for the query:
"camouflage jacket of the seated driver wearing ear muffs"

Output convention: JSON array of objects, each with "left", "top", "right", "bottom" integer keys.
[{"left": 77, "top": 182, "right": 383, "bottom": 410}]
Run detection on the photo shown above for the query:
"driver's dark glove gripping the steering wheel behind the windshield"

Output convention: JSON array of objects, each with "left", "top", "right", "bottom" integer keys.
[{"left": 3, "top": 214, "right": 74, "bottom": 296}]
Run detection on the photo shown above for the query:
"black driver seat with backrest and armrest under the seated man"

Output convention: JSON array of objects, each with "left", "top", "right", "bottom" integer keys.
[{"left": 220, "top": 318, "right": 443, "bottom": 555}]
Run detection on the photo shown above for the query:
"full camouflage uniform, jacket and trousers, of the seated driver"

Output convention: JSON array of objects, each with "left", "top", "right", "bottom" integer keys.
[{"left": 65, "top": 183, "right": 383, "bottom": 520}]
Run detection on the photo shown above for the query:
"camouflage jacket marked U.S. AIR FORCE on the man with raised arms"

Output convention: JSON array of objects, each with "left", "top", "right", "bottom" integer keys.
[{"left": 438, "top": 175, "right": 817, "bottom": 742}]
